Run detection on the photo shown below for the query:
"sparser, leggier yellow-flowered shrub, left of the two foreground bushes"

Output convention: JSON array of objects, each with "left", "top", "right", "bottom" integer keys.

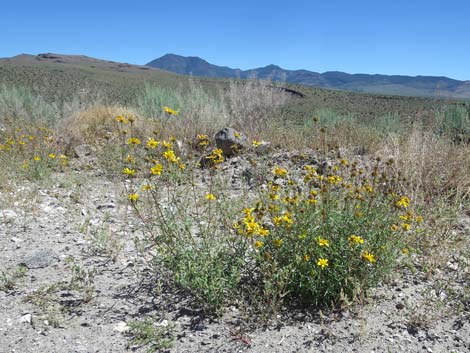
[{"left": 118, "top": 131, "right": 244, "bottom": 313}]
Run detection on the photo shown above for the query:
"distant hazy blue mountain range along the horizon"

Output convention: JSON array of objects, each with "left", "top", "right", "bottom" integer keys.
[{"left": 146, "top": 54, "right": 470, "bottom": 99}]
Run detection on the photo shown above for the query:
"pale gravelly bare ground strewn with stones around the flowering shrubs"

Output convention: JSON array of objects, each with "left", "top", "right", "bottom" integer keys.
[{"left": 0, "top": 152, "right": 470, "bottom": 353}]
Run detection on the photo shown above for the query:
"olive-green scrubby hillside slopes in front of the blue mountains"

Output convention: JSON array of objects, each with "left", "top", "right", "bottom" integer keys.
[{"left": 0, "top": 54, "right": 466, "bottom": 118}]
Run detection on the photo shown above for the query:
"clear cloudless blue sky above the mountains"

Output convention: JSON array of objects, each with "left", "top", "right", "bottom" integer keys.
[{"left": 0, "top": 0, "right": 470, "bottom": 80}]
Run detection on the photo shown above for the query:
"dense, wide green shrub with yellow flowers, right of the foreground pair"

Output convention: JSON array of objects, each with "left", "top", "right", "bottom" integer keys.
[{"left": 234, "top": 160, "right": 422, "bottom": 307}]
